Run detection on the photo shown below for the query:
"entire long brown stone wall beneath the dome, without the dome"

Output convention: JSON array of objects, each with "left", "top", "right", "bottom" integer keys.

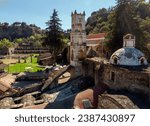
[{"left": 83, "top": 59, "right": 150, "bottom": 92}]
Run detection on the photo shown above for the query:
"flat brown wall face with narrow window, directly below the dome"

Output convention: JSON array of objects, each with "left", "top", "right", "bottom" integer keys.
[{"left": 103, "top": 65, "right": 150, "bottom": 88}]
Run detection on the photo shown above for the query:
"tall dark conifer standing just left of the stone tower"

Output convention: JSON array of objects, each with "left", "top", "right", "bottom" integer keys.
[{"left": 43, "top": 9, "right": 63, "bottom": 56}]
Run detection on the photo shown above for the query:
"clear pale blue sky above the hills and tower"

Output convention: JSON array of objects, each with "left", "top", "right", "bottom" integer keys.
[{"left": 0, "top": 0, "right": 116, "bottom": 30}]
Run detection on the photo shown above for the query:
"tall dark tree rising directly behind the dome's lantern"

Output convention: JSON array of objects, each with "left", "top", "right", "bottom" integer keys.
[{"left": 105, "top": 0, "right": 143, "bottom": 52}]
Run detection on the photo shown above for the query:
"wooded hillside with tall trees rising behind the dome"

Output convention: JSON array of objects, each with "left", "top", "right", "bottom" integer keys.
[{"left": 86, "top": 0, "right": 150, "bottom": 55}]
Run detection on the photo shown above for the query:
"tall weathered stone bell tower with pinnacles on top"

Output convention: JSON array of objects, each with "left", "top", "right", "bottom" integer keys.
[{"left": 70, "top": 11, "right": 86, "bottom": 75}]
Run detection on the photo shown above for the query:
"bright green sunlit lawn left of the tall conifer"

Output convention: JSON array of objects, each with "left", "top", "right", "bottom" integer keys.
[{"left": 5, "top": 57, "right": 44, "bottom": 73}]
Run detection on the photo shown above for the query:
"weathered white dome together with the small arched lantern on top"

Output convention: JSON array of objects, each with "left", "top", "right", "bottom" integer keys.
[{"left": 110, "top": 34, "right": 148, "bottom": 66}]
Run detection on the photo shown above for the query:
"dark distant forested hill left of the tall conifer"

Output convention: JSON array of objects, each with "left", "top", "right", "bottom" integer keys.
[{"left": 0, "top": 22, "right": 43, "bottom": 41}]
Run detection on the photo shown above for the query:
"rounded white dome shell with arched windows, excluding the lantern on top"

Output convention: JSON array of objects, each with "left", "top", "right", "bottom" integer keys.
[{"left": 110, "top": 47, "right": 148, "bottom": 66}]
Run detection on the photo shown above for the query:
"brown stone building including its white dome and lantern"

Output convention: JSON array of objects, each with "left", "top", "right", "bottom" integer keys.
[{"left": 83, "top": 34, "right": 150, "bottom": 88}]
